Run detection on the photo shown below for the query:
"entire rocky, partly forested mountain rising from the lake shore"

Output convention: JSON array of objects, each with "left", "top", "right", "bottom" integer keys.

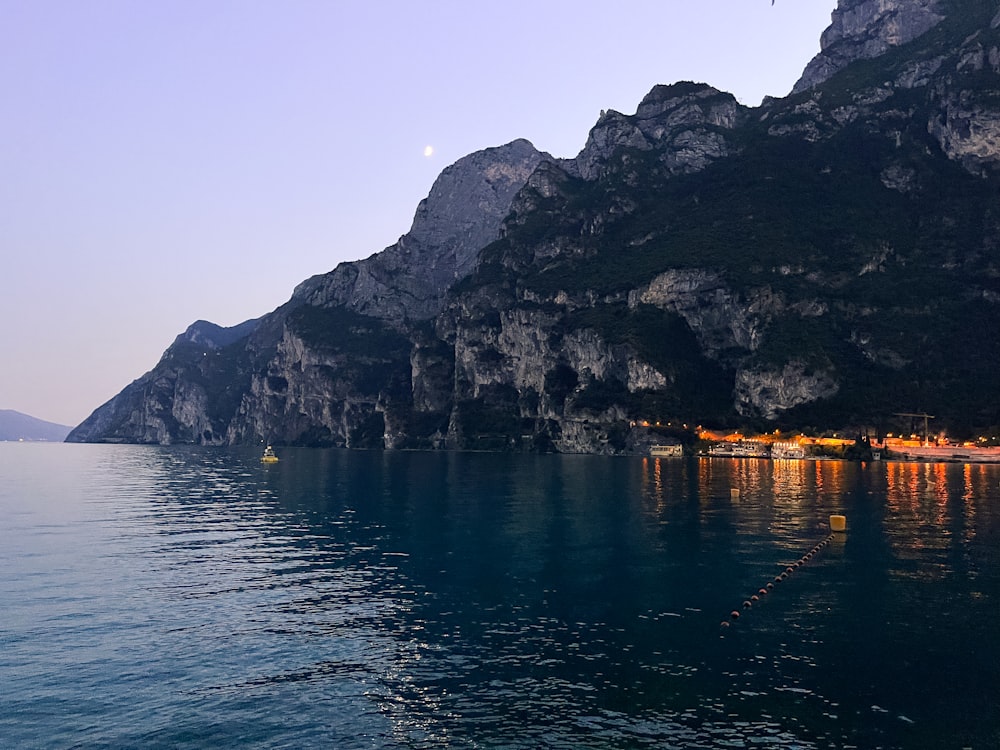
[{"left": 69, "top": 0, "right": 1000, "bottom": 453}]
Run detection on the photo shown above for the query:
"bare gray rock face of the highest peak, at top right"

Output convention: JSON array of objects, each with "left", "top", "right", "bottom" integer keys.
[{"left": 792, "top": 0, "right": 944, "bottom": 93}]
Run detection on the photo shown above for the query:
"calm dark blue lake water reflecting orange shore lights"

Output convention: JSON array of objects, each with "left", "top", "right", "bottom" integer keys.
[{"left": 0, "top": 443, "right": 1000, "bottom": 750}]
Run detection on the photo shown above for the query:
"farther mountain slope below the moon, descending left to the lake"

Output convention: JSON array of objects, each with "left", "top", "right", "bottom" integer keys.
[{"left": 68, "top": 140, "right": 547, "bottom": 446}]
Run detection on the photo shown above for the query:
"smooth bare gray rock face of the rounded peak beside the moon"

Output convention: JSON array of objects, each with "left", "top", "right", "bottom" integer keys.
[{"left": 293, "top": 140, "right": 551, "bottom": 320}]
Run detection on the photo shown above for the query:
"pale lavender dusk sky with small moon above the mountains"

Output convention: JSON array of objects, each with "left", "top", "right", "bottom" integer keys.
[{"left": 0, "top": 0, "right": 836, "bottom": 425}]
